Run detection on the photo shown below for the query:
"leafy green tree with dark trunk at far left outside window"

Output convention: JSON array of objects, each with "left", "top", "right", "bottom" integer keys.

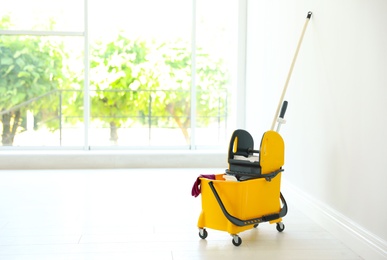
[{"left": 0, "top": 15, "right": 67, "bottom": 145}]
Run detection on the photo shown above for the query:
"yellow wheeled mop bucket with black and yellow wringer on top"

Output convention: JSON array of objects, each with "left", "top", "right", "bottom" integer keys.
[{"left": 197, "top": 129, "right": 287, "bottom": 246}]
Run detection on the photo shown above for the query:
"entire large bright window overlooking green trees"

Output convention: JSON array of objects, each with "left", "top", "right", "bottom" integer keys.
[{"left": 0, "top": 0, "right": 238, "bottom": 149}]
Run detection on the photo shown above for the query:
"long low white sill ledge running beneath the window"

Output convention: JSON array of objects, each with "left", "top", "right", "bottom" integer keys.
[{"left": 0, "top": 150, "right": 227, "bottom": 170}]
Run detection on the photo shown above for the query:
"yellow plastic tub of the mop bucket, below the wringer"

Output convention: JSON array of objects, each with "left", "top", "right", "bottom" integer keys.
[{"left": 198, "top": 173, "right": 281, "bottom": 234}]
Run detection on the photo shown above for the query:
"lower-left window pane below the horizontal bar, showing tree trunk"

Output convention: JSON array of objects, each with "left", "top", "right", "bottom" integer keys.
[{"left": 0, "top": 35, "right": 84, "bottom": 146}]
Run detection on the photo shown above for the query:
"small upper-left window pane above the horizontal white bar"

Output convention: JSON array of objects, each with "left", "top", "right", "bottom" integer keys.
[{"left": 0, "top": 0, "right": 84, "bottom": 32}]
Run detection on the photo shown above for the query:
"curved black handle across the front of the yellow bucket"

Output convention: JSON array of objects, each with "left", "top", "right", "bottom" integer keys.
[{"left": 208, "top": 181, "right": 288, "bottom": 227}]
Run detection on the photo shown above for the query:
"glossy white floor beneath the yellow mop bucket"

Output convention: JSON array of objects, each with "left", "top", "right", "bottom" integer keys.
[{"left": 0, "top": 169, "right": 361, "bottom": 260}]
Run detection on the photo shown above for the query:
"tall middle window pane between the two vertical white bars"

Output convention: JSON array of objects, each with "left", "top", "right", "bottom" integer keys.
[{"left": 90, "top": 0, "right": 192, "bottom": 146}]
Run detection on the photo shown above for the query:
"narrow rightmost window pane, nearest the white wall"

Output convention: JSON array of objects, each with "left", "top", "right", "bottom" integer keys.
[{"left": 196, "top": 0, "right": 238, "bottom": 145}]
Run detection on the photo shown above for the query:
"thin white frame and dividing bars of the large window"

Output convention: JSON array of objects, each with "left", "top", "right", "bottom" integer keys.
[{"left": 0, "top": 0, "right": 247, "bottom": 151}]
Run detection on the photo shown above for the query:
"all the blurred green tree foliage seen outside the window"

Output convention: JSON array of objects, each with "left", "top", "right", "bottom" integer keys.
[{"left": 0, "top": 17, "right": 229, "bottom": 145}]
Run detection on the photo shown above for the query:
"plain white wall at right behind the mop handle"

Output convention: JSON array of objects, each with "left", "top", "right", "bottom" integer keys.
[{"left": 246, "top": 0, "right": 387, "bottom": 245}]
